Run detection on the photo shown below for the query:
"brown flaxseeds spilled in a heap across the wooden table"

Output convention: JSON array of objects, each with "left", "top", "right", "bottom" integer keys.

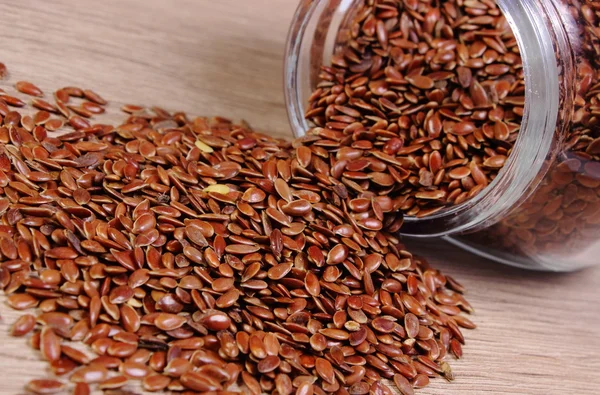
[{"left": 0, "top": 62, "right": 474, "bottom": 395}]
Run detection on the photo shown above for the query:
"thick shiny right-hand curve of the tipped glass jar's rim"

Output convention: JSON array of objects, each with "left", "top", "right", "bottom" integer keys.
[{"left": 402, "top": 0, "right": 575, "bottom": 237}]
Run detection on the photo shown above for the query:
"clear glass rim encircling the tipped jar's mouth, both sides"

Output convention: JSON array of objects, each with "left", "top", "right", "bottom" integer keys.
[{"left": 284, "top": 0, "right": 568, "bottom": 237}]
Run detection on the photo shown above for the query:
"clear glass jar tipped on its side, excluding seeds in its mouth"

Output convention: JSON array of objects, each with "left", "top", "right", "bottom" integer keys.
[{"left": 285, "top": 0, "right": 600, "bottom": 271}]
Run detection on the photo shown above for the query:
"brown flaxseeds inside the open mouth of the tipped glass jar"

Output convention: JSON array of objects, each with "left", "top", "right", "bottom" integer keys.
[{"left": 305, "top": 0, "right": 524, "bottom": 217}]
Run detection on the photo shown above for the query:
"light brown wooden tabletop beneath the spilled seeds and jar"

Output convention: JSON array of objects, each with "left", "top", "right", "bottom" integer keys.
[{"left": 0, "top": 0, "right": 600, "bottom": 395}]
